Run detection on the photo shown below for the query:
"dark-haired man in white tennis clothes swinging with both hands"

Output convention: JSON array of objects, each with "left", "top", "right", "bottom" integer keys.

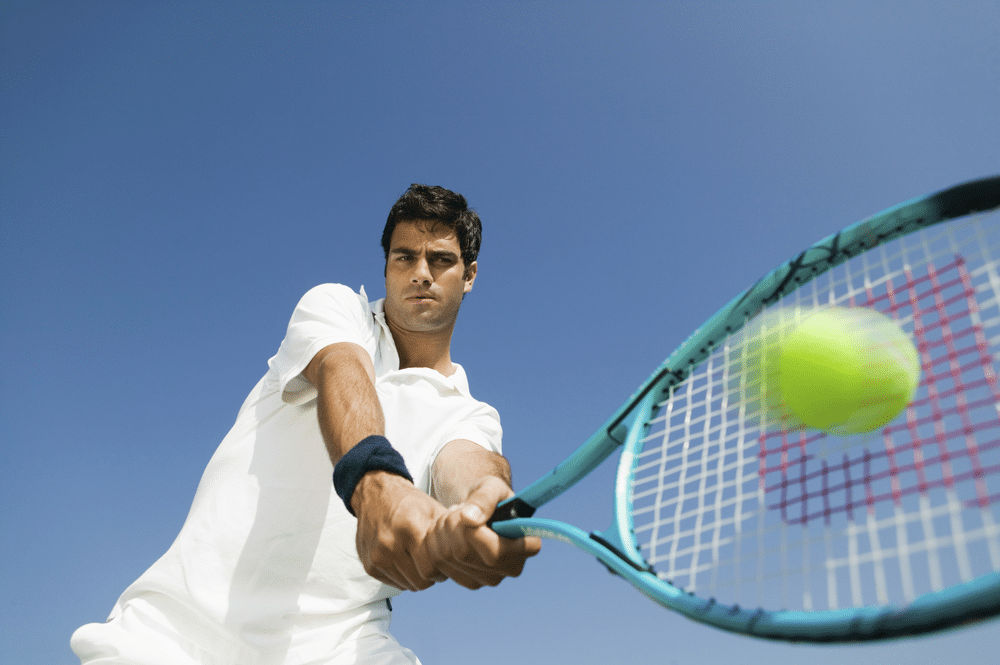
[{"left": 71, "top": 185, "right": 541, "bottom": 665}]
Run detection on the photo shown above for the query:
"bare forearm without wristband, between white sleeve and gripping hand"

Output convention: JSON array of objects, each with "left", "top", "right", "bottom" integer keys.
[{"left": 432, "top": 439, "right": 511, "bottom": 506}]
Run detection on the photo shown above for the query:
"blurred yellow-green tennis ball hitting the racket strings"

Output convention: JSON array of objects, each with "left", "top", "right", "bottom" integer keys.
[{"left": 778, "top": 307, "right": 920, "bottom": 435}]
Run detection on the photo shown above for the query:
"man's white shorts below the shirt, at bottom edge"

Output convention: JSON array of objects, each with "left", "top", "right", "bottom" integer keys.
[{"left": 70, "top": 597, "right": 420, "bottom": 665}]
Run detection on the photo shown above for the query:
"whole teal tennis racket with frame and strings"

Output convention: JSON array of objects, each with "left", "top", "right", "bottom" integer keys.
[{"left": 491, "top": 176, "right": 1000, "bottom": 642}]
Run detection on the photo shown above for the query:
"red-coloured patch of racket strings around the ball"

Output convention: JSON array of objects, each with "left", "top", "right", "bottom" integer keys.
[{"left": 758, "top": 256, "right": 1000, "bottom": 525}]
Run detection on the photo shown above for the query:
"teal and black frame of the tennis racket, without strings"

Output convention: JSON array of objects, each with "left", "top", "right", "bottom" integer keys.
[{"left": 490, "top": 176, "right": 1000, "bottom": 642}]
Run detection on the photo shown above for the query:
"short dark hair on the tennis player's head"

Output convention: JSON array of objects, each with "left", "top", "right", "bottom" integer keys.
[{"left": 382, "top": 184, "right": 483, "bottom": 270}]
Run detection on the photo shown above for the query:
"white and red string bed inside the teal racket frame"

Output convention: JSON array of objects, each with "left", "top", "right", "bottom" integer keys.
[{"left": 632, "top": 213, "right": 1000, "bottom": 610}]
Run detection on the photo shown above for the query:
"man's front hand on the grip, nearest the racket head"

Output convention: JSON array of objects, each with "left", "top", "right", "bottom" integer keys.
[{"left": 417, "top": 476, "right": 542, "bottom": 589}]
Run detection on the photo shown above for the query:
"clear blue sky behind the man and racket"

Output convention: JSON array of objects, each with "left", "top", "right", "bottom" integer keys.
[{"left": 0, "top": 0, "right": 1000, "bottom": 665}]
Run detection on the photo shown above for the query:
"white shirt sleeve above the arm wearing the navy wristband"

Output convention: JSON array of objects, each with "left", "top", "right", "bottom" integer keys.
[{"left": 268, "top": 284, "right": 377, "bottom": 404}]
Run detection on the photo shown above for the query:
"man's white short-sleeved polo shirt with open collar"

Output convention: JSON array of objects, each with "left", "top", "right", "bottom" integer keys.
[{"left": 72, "top": 284, "right": 501, "bottom": 660}]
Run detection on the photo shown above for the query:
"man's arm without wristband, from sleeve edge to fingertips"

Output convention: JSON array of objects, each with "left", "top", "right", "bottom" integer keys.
[{"left": 422, "top": 439, "right": 542, "bottom": 589}]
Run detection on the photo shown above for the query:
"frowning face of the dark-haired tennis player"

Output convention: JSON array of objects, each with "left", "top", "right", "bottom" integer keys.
[{"left": 385, "top": 220, "right": 476, "bottom": 332}]
